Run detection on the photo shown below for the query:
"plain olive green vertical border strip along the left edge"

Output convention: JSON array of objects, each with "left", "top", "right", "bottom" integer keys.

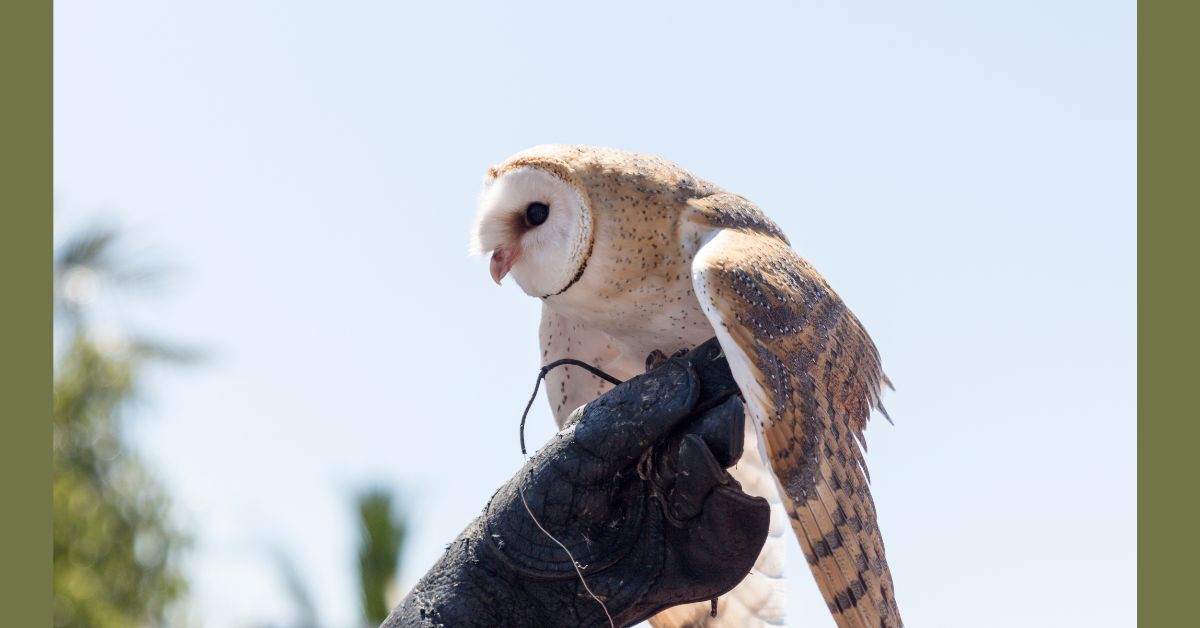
[{"left": 0, "top": 0, "right": 53, "bottom": 627}]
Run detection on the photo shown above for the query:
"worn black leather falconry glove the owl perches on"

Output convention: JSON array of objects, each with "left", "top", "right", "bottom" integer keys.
[{"left": 384, "top": 339, "right": 769, "bottom": 627}]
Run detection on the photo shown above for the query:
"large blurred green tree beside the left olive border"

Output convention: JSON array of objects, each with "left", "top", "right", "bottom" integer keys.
[{"left": 53, "top": 229, "right": 188, "bottom": 628}]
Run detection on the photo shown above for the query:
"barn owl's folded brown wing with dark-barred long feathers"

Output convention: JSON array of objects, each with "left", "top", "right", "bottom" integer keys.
[{"left": 691, "top": 195, "right": 902, "bottom": 628}]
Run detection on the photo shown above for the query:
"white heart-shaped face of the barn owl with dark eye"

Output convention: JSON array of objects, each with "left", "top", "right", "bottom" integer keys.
[{"left": 472, "top": 166, "right": 592, "bottom": 297}]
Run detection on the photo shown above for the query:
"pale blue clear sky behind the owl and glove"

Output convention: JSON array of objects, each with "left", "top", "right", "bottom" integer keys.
[{"left": 55, "top": 0, "right": 1136, "bottom": 627}]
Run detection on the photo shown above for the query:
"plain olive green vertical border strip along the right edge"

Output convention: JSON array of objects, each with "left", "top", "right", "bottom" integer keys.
[{"left": 1137, "top": 0, "right": 1200, "bottom": 626}]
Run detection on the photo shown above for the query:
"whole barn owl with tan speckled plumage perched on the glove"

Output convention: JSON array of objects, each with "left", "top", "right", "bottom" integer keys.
[{"left": 473, "top": 145, "right": 901, "bottom": 628}]
